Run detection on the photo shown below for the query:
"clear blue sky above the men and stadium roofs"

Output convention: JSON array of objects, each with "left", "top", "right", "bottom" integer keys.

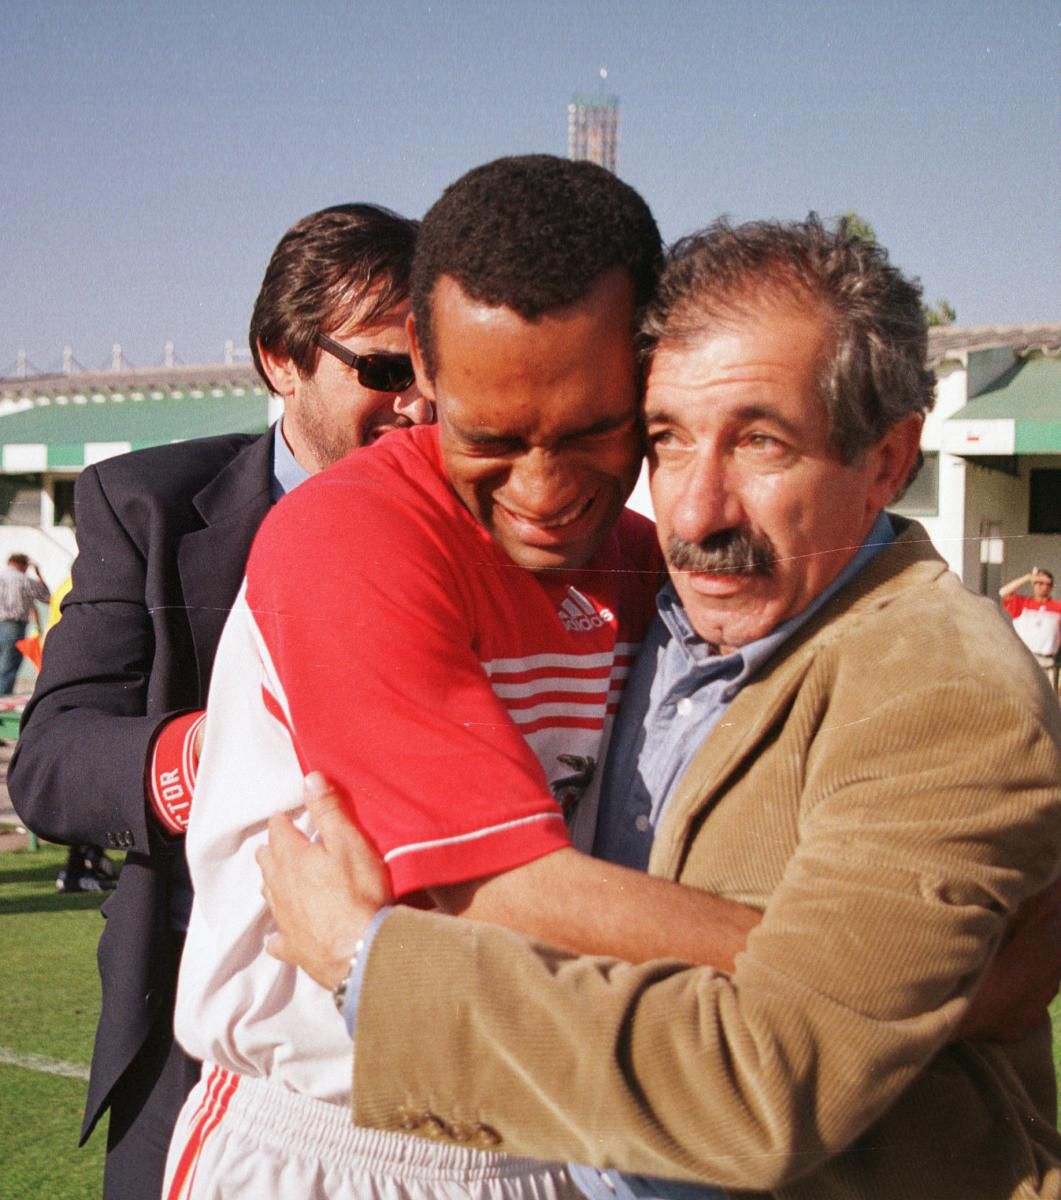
[{"left": 0, "top": 0, "right": 1061, "bottom": 373}]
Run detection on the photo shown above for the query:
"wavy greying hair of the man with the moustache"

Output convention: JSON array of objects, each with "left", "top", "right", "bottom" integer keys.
[{"left": 641, "top": 212, "right": 935, "bottom": 465}]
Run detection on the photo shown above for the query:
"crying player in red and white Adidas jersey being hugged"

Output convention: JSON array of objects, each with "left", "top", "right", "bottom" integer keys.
[{"left": 164, "top": 156, "right": 755, "bottom": 1200}]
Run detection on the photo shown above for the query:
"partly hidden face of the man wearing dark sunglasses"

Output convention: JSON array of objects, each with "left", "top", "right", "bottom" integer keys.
[{"left": 259, "top": 295, "right": 431, "bottom": 472}]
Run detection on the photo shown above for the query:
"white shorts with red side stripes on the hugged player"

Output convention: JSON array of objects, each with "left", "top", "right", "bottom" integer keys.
[{"left": 162, "top": 1063, "right": 582, "bottom": 1200}]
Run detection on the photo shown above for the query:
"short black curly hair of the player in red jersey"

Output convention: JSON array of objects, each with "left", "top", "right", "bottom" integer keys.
[{"left": 413, "top": 155, "right": 663, "bottom": 377}]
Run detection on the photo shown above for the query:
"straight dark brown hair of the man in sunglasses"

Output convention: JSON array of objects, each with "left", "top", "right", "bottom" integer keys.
[{"left": 250, "top": 204, "right": 420, "bottom": 389}]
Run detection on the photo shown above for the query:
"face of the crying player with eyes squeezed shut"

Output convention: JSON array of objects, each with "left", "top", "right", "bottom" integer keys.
[{"left": 412, "top": 270, "right": 641, "bottom": 571}]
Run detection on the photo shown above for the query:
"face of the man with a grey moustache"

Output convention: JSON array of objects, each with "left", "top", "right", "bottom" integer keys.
[{"left": 646, "top": 304, "right": 921, "bottom": 652}]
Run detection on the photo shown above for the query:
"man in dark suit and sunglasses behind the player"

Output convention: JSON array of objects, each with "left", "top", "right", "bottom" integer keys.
[{"left": 8, "top": 204, "right": 430, "bottom": 1200}]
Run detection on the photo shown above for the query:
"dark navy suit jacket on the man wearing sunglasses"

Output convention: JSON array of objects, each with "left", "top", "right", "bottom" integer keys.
[{"left": 7, "top": 433, "right": 272, "bottom": 1140}]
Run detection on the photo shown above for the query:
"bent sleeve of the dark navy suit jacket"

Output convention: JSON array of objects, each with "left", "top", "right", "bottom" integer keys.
[{"left": 7, "top": 467, "right": 182, "bottom": 851}]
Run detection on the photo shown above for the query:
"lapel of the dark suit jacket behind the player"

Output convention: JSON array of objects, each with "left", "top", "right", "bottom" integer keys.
[{"left": 178, "top": 431, "right": 275, "bottom": 703}]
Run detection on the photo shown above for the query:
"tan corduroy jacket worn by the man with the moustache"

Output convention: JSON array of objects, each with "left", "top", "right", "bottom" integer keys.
[{"left": 354, "top": 522, "right": 1061, "bottom": 1200}]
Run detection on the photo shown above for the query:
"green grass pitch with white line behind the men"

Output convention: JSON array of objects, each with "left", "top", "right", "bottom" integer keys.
[{"left": 0, "top": 846, "right": 1061, "bottom": 1200}]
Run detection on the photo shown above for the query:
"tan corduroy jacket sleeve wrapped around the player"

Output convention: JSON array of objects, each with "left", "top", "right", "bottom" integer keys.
[{"left": 354, "top": 680, "right": 1061, "bottom": 1189}]
